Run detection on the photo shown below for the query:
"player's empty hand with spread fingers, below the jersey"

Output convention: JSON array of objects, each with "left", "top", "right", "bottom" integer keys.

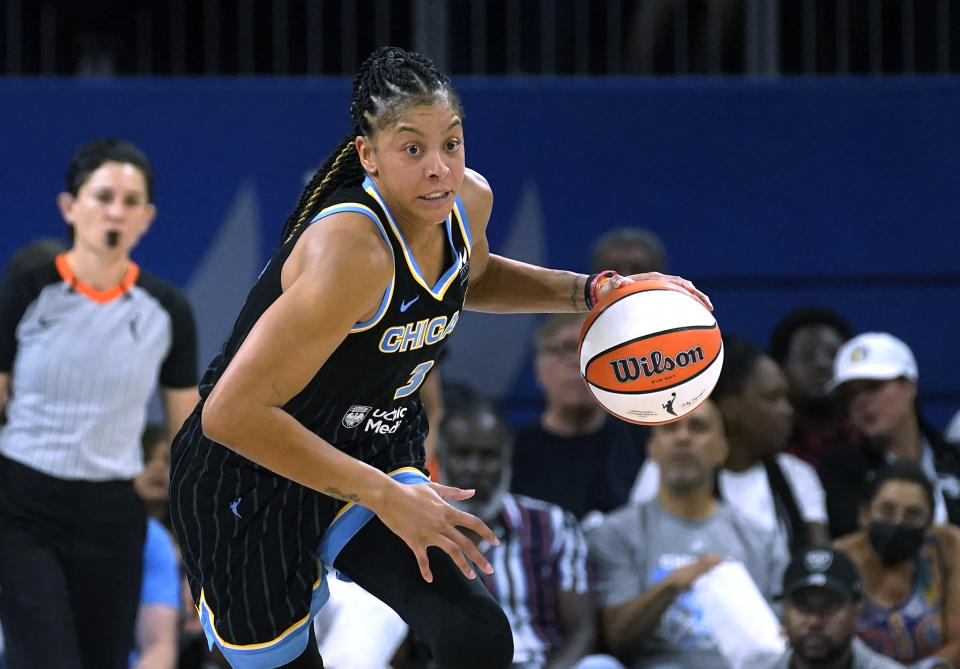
[{"left": 377, "top": 482, "right": 500, "bottom": 583}]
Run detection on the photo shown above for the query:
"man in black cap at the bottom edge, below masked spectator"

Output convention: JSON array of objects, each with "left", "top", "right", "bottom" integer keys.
[{"left": 772, "top": 548, "right": 903, "bottom": 669}]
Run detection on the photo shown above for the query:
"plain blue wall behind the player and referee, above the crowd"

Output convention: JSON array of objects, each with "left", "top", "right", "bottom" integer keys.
[{"left": 0, "top": 78, "right": 960, "bottom": 425}]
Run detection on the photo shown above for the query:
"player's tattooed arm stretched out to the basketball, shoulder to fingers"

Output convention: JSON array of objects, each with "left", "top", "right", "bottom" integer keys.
[{"left": 460, "top": 169, "right": 713, "bottom": 313}]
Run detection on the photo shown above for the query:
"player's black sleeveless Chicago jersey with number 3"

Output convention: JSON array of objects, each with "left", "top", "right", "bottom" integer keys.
[{"left": 200, "top": 177, "right": 471, "bottom": 464}]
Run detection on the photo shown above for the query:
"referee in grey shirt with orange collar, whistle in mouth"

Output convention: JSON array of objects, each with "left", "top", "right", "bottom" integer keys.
[{"left": 0, "top": 139, "right": 198, "bottom": 669}]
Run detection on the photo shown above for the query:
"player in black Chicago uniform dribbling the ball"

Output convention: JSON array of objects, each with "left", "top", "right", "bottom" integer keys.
[{"left": 171, "top": 47, "right": 706, "bottom": 669}]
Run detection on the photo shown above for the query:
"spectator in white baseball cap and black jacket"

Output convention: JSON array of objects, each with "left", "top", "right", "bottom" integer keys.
[{"left": 818, "top": 332, "right": 960, "bottom": 537}]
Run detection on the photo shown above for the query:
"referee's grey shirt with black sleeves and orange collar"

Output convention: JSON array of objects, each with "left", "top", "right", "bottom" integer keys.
[{"left": 0, "top": 255, "right": 197, "bottom": 481}]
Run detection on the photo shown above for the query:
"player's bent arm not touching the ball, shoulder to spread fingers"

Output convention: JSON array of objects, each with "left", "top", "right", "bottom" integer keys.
[{"left": 202, "top": 213, "right": 495, "bottom": 580}]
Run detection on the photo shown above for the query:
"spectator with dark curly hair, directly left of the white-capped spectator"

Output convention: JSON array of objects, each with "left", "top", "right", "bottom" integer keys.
[{"left": 770, "top": 307, "right": 855, "bottom": 467}]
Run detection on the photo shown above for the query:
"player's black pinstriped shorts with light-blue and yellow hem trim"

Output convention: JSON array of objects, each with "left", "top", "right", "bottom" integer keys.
[{"left": 170, "top": 420, "right": 428, "bottom": 669}]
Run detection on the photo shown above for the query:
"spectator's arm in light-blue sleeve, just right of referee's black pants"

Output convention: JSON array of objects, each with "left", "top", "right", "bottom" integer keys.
[{"left": 130, "top": 518, "right": 181, "bottom": 669}]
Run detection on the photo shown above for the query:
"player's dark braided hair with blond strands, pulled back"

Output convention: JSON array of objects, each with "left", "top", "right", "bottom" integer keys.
[{"left": 280, "top": 46, "right": 463, "bottom": 243}]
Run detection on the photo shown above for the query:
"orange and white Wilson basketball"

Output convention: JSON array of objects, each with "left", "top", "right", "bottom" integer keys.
[{"left": 579, "top": 280, "right": 723, "bottom": 425}]
